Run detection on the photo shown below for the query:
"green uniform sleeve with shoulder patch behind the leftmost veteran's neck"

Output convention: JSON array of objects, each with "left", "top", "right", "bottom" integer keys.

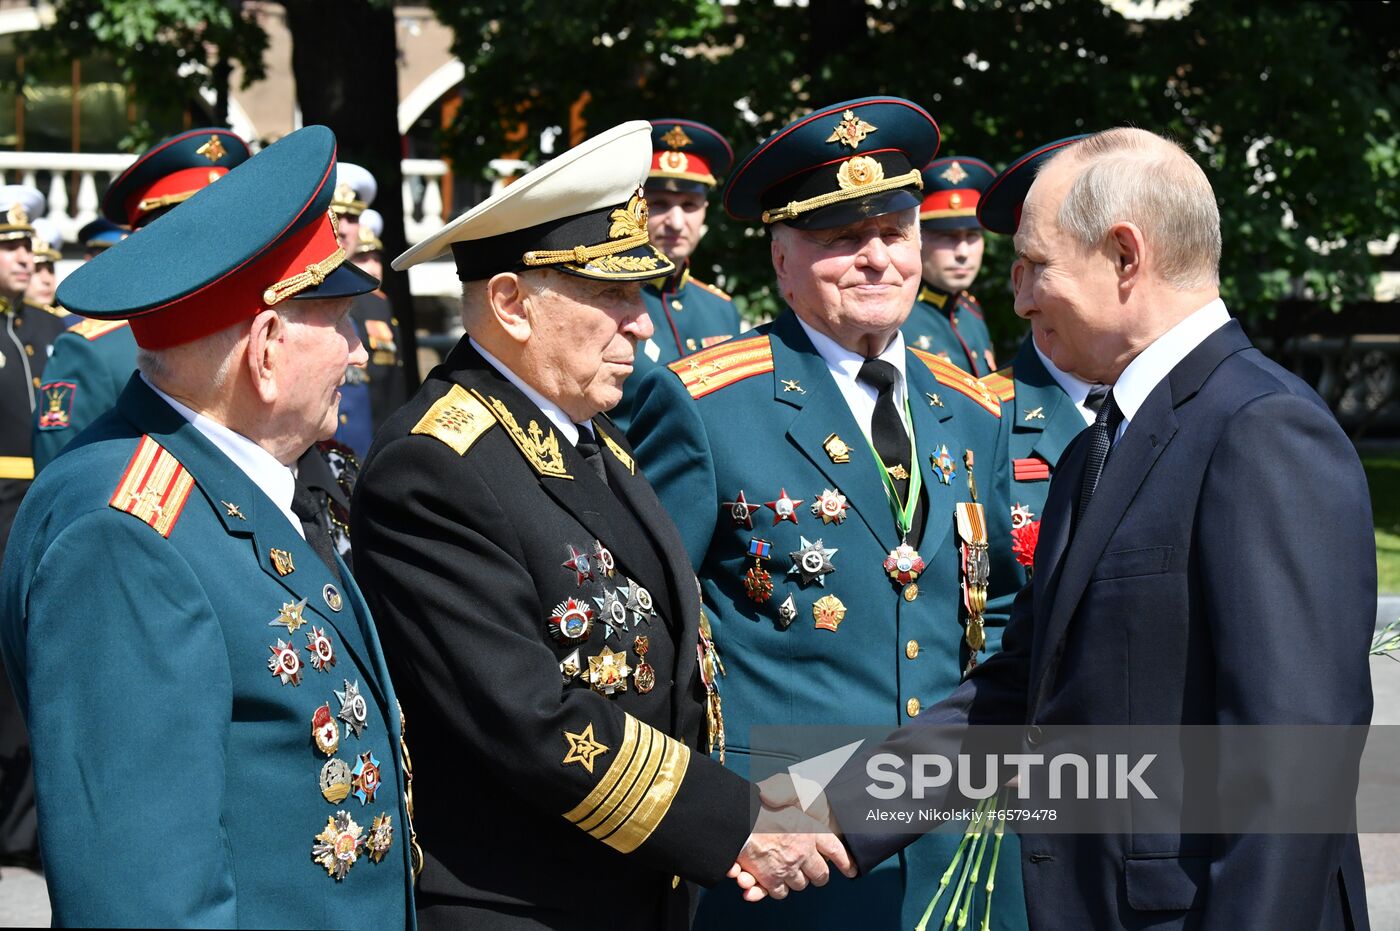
[{"left": 32, "top": 319, "right": 136, "bottom": 473}]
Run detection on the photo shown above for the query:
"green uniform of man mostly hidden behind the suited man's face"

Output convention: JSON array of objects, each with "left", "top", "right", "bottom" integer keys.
[{"left": 983, "top": 336, "right": 1088, "bottom": 578}]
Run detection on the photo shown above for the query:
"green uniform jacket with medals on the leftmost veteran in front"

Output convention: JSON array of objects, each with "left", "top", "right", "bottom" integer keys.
[{"left": 0, "top": 375, "right": 413, "bottom": 928}]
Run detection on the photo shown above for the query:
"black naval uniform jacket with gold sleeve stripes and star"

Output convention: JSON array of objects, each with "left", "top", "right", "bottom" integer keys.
[{"left": 351, "top": 339, "right": 750, "bottom": 931}]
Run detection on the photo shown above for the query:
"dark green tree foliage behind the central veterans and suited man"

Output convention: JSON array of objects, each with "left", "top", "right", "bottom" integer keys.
[{"left": 433, "top": 0, "right": 1400, "bottom": 339}]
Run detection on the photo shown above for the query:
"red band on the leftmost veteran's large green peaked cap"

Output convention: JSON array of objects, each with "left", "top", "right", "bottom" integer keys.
[{"left": 130, "top": 213, "right": 340, "bottom": 349}]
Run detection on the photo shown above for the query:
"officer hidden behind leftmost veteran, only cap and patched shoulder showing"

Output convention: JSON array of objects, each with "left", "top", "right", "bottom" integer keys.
[{"left": 32, "top": 127, "right": 252, "bottom": 472}]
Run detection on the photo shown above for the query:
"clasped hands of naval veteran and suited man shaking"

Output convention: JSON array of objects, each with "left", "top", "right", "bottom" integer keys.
[{"left": 728, "top": 776, "right": 855, "bottom": 902}]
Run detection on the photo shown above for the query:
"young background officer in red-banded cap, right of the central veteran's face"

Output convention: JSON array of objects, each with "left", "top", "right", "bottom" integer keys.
[{"left": 900, "top": 157, "right": 997, "bottom": 377}]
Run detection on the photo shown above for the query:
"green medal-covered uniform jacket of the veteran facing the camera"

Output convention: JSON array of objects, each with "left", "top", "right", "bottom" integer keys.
[{"left": 630, "top": 308, "right": 1025, "bottom": 928}]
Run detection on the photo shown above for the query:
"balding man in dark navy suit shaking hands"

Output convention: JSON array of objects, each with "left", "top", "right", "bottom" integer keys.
[{"left": 800, "top": 129, "right": 1376, "bottom": 928}]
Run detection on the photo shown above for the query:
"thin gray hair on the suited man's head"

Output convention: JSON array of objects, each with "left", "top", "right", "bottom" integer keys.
[{"left": 1056, "top": 127, "right": 1221, "bottom": 290}]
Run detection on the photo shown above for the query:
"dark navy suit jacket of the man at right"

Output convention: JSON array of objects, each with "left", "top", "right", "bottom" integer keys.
[{"left": 832, "top": 321, "right": 1376, "bottom": 928}]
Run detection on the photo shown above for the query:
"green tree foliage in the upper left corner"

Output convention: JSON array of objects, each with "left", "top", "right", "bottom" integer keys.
[{"left": 25, "top": 0, "right": 267, "bottom": 148}]
